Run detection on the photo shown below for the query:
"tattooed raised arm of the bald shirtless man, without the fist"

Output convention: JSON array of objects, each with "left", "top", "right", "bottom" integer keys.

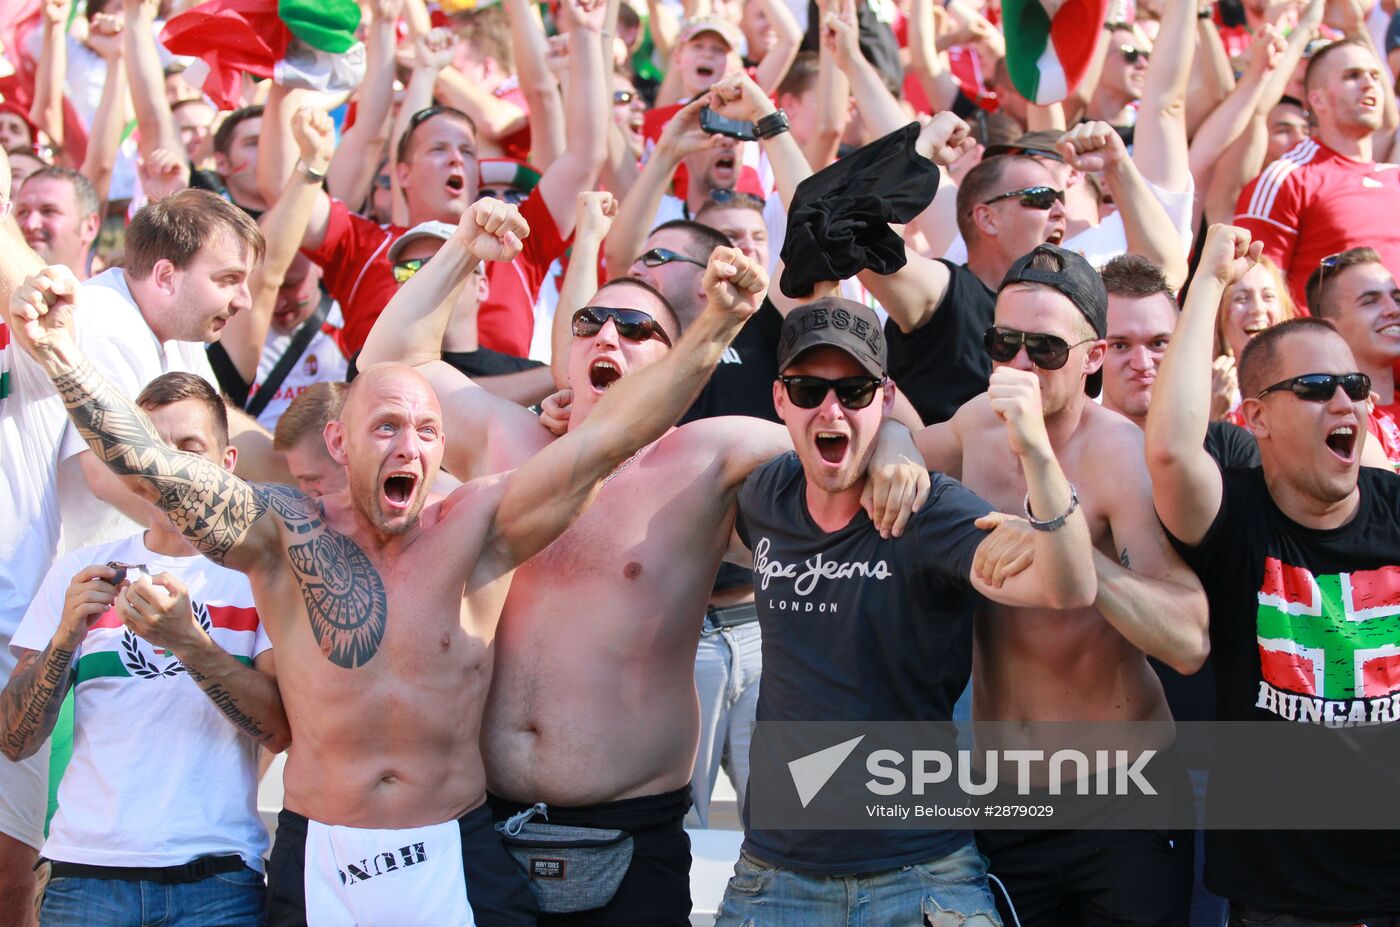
[{"left": 53, "top": 358, "right": 266, "bottom": 563}]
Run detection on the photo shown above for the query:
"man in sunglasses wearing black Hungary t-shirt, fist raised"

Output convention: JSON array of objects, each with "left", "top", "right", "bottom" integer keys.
[{"left": 1147, "top": 225, "right": 1400, "bottom": 927}]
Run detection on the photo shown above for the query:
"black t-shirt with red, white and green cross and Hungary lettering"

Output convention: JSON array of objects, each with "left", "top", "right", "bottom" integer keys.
[{"left": 1173, "top": 466, "right": 1400, "bottom": 923}]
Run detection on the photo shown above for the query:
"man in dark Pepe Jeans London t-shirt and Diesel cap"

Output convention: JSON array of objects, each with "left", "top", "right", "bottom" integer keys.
[{"left": 715, "top": 298, "right": 1093, "bottom": 927}]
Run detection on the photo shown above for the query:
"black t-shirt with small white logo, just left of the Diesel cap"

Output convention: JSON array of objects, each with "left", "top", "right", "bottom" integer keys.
[{"left": 680, "top": 298, "right": 783, "bottom": 424}]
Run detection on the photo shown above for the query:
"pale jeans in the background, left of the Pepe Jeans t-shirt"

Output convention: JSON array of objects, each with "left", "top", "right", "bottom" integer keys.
[{"left": 686, "top": 622, "right": 763, "bottom": 828}]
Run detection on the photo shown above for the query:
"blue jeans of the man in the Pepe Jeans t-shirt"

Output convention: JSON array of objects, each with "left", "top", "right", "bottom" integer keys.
[{"left": 714, "top": 843, "right": 1001, "bottom": 927}]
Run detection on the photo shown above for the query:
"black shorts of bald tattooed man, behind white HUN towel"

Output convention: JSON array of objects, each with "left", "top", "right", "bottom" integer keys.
[{"left": 267, "top": 805, "right": 539, "bottom": 927}]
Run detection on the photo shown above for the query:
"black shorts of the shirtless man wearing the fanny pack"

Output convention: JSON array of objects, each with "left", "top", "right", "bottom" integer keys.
[{"left": 486, "top": 786, "right": 690, "bottom": 927}]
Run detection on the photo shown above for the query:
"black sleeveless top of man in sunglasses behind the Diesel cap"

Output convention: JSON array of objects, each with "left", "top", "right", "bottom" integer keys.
[{"left": 885, "top": 260, "right": 997, "bottom": 424}]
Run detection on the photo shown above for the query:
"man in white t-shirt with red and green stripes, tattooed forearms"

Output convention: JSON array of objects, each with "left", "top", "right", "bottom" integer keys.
[{"left": 0, "top": 372, "right": 291, "bottom": 927}]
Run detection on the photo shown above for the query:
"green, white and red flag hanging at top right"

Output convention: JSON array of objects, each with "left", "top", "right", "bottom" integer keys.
[{"left": 1001, "top": 0, "right": 1109, "bottom": 105}]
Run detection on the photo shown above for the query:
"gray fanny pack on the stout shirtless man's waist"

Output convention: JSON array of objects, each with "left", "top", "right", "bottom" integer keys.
[{"left": 496, "top": 802, "right": 631, "bottom": 914}]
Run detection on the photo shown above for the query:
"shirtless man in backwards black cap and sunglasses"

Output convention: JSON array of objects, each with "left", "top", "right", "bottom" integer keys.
[{"left": 918, "top": 245, "right": 1208, "bottom": 926}]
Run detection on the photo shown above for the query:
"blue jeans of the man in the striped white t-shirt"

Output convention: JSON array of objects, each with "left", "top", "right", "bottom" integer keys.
[{"left": 39, "top": 867, "right": 266, "bottom": 927}]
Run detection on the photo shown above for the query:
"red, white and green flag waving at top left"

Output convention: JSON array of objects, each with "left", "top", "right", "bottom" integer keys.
[{"left": 161, "top": 0, "right": 364, "bottom": 109}]
